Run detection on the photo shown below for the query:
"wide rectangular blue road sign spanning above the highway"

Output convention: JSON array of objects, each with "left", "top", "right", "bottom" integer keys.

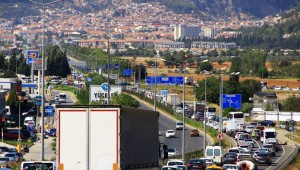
[{"left": 146, "top": 76, "right": 183, "bottom": 85}]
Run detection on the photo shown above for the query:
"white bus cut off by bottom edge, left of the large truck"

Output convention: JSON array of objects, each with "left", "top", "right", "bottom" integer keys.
[{"left": 20, "top": 161, "right": 56, "bottom": 170}]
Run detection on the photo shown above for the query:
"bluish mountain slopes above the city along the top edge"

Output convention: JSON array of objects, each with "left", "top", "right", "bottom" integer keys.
[{"left": 0, "top": 0, "right": 300, "bottom": 21}]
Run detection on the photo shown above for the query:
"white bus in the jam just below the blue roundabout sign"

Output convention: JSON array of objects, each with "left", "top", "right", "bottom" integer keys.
[{"left": 223, "top": 112, "right": 245, "bottom": 132}]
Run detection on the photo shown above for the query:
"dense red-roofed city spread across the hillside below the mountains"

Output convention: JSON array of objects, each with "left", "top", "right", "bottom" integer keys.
[{"left": 0, "top": 3, "right": 280, "bottom": 51}]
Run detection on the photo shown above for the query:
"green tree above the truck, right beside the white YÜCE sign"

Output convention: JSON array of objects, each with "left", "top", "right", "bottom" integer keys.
[{"left": 111, "top": 93, "right": 139, "bottom": 108}]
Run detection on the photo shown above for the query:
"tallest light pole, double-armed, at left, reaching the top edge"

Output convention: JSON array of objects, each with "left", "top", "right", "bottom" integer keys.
[{"left": 28, "top": 0, "right": 61, "bottom": 161}]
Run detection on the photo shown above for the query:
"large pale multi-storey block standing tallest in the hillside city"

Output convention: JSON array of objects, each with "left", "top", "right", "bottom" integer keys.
[{"left": 174, "top": 24, "right": 200, "bottom": 40}]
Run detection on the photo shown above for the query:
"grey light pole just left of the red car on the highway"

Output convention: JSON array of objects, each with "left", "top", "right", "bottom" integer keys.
[{"left": 160, "top": 58, "right": 185, "bottom": 160}]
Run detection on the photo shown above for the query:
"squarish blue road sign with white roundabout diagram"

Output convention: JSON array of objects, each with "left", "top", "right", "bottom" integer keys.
[{"left": 222, "top": 94, "right": 242, "bottom": 109}]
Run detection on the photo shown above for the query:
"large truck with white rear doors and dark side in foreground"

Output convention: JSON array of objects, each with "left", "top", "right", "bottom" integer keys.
[{"left": 55, "top": 105, "right": 160, "bottom": 170}]
